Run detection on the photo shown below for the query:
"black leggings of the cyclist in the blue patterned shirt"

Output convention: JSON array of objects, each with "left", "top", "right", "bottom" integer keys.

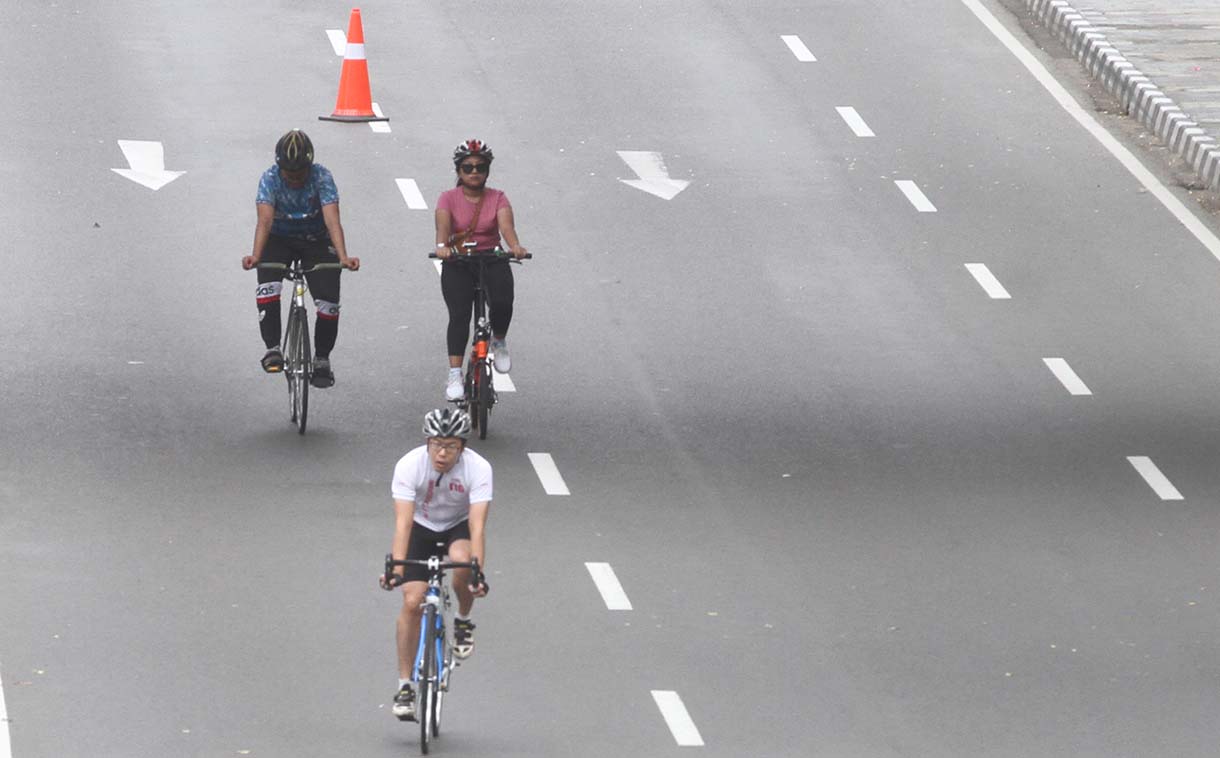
[{"left": 256, "top": 233, "right": 339, "bottom": 358}]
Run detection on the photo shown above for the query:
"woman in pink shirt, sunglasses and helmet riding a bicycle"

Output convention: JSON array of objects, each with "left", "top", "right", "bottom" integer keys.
[{"left": 437, "top": 139, "right": 527, "bottom": 400}]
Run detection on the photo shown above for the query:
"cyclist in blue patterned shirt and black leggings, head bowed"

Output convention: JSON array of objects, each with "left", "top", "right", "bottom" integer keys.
[{"left": 242, "top": 129, "right": 360, "bottom": 389}]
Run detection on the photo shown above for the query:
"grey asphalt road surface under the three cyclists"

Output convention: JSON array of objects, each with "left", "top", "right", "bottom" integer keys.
[{"left": 0, "top": 0, "right": 1220, "bottom": 758}]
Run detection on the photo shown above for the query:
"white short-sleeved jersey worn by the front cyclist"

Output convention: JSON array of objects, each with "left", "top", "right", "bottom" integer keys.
[{"left": 390, "top": 444, "right": 492, "bottom": 532}]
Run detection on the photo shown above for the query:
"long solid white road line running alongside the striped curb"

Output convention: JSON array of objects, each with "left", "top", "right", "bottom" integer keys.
[{"left": 961, "top": 0, "right": 1220, "bottom": 260}]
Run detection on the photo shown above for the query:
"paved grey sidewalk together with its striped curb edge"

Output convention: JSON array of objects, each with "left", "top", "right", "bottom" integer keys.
[{"left": 1026, "top": 0, "right": 1220, "bottom": 189}]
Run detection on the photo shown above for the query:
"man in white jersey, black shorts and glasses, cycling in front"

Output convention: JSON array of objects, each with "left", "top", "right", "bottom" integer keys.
[{"left": 382, "top": 408, "right": 492, "bottom": 721}]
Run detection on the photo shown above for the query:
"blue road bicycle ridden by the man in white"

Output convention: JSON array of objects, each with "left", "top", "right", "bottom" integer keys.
[{"left": 382, "top": 555, "right": 487, "bottom": 754}]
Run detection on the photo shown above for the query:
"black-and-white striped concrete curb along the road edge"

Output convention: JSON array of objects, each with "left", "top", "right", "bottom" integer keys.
[{"left": 1025, "top": 0, "right": 1220, "bottom": 189}]
